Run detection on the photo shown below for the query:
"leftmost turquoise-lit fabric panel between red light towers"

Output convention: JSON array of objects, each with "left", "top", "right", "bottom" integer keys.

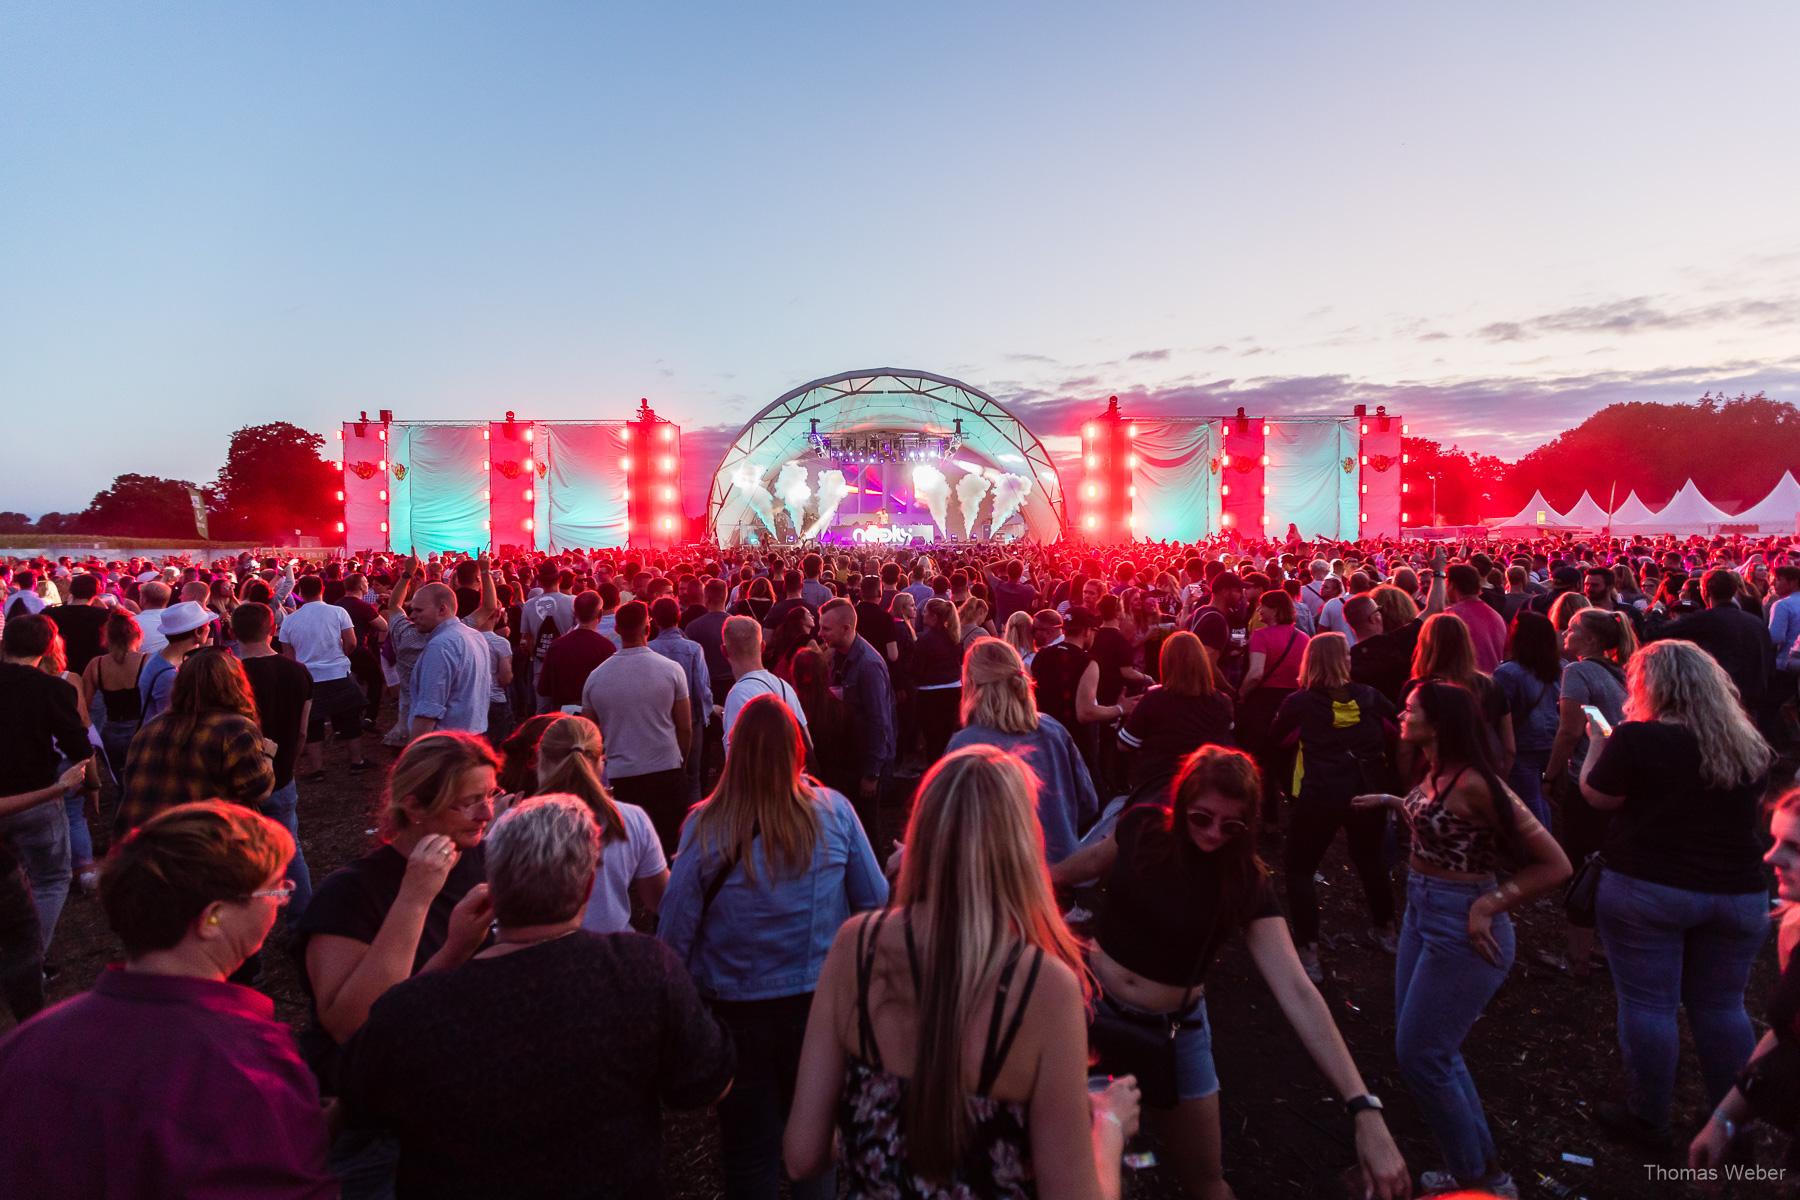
[{"left": 389, "top": 425, "right": 491, "bottom": 554}]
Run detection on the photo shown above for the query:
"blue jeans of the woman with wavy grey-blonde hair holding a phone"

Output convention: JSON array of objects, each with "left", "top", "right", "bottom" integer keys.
[{"left": 1595, "top": 871, "right": 1769, "bottom": 1128}]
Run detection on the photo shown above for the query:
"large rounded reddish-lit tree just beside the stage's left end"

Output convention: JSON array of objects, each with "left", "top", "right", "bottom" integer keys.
[{"left": 212, "top": 421, "right": 342, "bottom": 538}]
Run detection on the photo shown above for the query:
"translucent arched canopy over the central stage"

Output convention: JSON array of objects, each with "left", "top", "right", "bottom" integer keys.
[{"left": 706, "top": 367, "right": 1064, "bottom": 542}]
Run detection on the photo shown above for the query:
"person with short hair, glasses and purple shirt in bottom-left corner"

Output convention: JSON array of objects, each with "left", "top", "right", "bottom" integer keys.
[{"left": 0, "top": 801, "right": 338, "bottom": 1200}]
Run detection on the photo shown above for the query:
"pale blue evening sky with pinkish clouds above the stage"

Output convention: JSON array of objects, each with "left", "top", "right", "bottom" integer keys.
[{"left": 0, "top": 0, "right": 1800, "bottom": 515}]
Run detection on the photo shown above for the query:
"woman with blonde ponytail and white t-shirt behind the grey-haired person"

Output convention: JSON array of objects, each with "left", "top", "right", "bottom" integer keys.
[{"left": 531, "top": 712, "right": 670, "bottom": 934}]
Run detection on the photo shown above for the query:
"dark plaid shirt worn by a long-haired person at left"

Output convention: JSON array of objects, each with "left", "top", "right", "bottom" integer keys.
[{"left": 113, "top": 712, "right": 275, "bottom": 835}]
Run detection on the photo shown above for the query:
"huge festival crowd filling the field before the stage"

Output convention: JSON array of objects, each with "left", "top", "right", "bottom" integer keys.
[{"left": 0, "top": 536, "right": 1800, "bottom": 1200}]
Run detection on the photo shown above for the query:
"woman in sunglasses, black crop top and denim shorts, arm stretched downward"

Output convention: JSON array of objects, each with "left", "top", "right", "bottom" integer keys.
[{"left": 1051, "top": 747, "right": 1409, "bottom": 1200}]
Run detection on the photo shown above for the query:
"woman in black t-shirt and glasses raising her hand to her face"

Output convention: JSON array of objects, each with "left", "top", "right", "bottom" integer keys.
[{"left": 290, "top": 732, "right": 500, "bottom": 1200}]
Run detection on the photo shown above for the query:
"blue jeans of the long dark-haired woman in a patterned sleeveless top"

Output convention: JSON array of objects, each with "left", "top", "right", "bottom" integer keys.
[{"left": 1393, "top": 871, "right": 1514, "bottom": 1186}]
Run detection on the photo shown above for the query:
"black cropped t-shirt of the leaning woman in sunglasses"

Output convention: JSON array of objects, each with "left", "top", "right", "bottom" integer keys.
[{"left": 1096, "top": 804, "right": 1282, "bottom": 988}]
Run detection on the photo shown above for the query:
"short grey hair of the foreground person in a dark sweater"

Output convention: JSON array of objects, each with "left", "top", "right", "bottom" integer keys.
[{"left": 482, "top": 793, "right": 599, "bottom": 928}]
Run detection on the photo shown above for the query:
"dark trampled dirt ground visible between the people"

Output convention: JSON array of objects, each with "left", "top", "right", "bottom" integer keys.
[{"left": 17, "top": 736, "right": 1791, "bottom": 1200}]
